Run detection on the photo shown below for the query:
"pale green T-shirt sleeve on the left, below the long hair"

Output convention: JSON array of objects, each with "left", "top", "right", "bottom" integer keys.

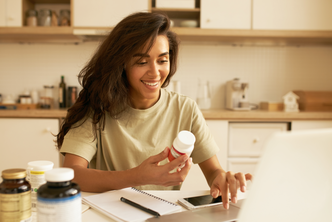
[{"left": 60, "top": 118, "right": 97, "bottom": 162}]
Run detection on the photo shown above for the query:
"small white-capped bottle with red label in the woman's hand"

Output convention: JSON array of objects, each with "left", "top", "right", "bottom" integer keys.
[{"left": 168, "top": 130, "right": 196, "bottom": 163}]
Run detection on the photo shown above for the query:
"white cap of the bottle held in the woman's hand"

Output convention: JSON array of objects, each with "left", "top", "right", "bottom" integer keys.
[{"left": 173, "top": 130, "right": 196, "bottom": 153}]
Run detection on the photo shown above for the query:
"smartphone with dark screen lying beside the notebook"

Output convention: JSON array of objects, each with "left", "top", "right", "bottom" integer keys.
[{"left": 178, "top": 195, "right": 222, "bottom": 210}]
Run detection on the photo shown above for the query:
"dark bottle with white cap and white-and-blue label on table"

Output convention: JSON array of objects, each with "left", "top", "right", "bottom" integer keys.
[{"left": 37, "top": 168, "right": 82, "bottom": 222}]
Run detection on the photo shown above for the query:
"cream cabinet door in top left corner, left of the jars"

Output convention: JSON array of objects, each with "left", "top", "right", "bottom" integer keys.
[{"left": 0, "top": 0, "right": 23, "bottom": 27}]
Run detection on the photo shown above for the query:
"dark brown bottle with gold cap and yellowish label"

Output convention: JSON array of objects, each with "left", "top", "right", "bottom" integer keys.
[{"left": 0, "top": 169, "right": 32, "bottom": 222}]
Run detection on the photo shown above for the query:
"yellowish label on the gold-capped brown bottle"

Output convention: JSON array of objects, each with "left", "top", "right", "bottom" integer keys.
[{"left": 0, "top": 191, "right": 32, "bottom": 222}]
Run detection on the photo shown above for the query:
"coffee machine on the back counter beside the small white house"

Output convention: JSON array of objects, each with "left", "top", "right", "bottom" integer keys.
[{"left": 226, "top": 78, "right": 251, "bottom": 110}]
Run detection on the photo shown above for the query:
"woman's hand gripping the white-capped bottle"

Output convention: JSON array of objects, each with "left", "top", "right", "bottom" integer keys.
[{"left": 135, "top": 147, "right": 192, "bottom": 186}]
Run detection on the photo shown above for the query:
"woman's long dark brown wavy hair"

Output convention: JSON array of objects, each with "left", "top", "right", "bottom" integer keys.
[{"left": 56, "top": 12, "right": 179, "bottom": 149}]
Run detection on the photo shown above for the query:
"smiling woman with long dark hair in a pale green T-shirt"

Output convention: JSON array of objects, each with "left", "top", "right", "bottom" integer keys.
[{"left": 57, "top": 13, "right": 251, "bottom": 208}]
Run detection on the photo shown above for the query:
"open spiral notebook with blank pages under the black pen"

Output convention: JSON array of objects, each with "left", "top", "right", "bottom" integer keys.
[{"left": 82, "top": 187, "right": 182, "bottom": 222}]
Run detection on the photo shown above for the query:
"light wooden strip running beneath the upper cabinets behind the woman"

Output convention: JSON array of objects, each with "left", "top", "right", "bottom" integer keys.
[{"left": 0, "top": 27, "right": 332, "bottom": 45}]
